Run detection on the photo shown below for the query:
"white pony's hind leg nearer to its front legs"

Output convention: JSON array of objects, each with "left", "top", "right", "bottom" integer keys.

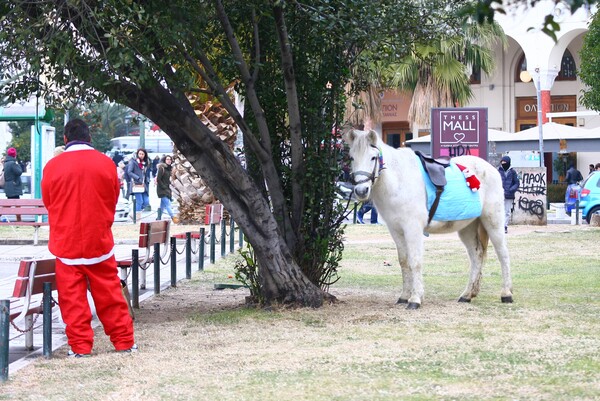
[{"left": 458, "top": 220, "right": 488, "bottom": 302}]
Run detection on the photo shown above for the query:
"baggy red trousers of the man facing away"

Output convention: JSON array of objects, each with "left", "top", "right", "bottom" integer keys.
[{"left": 56, "top": 256, "right": 134, "bottom": 354}]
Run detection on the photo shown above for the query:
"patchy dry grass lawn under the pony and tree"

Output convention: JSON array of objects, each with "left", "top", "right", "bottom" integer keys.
[{"left": 0, "top": 225, "right": 600, "bottom": 400}]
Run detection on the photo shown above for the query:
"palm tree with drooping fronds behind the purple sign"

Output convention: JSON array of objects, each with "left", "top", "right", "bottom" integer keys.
[{"left": 385, "top": 22, "right": 508, "bottom": 127}]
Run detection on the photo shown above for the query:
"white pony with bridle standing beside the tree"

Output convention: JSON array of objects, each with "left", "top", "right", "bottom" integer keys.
[{"left": 344, "top": 130, "right": 513, "bottom": 309}]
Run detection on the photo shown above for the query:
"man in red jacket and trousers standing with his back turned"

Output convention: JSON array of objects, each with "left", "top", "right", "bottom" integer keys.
[{"left": 42, "top": 119, "right": 137, "bottom": 357}]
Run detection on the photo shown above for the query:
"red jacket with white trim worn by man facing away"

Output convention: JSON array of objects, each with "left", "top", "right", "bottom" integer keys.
[{"left": 42, "top": 144, "right": 120, "bottom": 265}]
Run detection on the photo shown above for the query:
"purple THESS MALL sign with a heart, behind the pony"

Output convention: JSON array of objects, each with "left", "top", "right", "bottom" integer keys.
[{"left": 431, "top": 108, "right": 488, "bottom": 160}]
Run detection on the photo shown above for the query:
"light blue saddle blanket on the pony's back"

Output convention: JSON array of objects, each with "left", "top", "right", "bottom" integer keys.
[{"left": 415, "top": 156, "right": 481, "bottom": 221}]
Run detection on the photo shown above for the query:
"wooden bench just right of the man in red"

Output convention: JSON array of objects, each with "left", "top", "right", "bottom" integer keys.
[{"left": 117, "top": 220, "right": 170, "bottom": 290}]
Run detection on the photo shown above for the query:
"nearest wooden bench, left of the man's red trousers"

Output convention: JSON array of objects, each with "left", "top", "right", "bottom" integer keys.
[{"left": 1, "top": 258, "right": 56, "bottom": 350}]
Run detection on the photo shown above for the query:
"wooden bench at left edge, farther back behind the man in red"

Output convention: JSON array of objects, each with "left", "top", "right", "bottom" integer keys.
[{"left": 0, "top": 199, "right": 48, "bottom": 245}]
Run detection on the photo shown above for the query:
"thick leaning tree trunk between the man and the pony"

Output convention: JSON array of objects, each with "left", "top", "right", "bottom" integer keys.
[{"left": 136, "top": 83, "right": 324, "bottom": 307}]
